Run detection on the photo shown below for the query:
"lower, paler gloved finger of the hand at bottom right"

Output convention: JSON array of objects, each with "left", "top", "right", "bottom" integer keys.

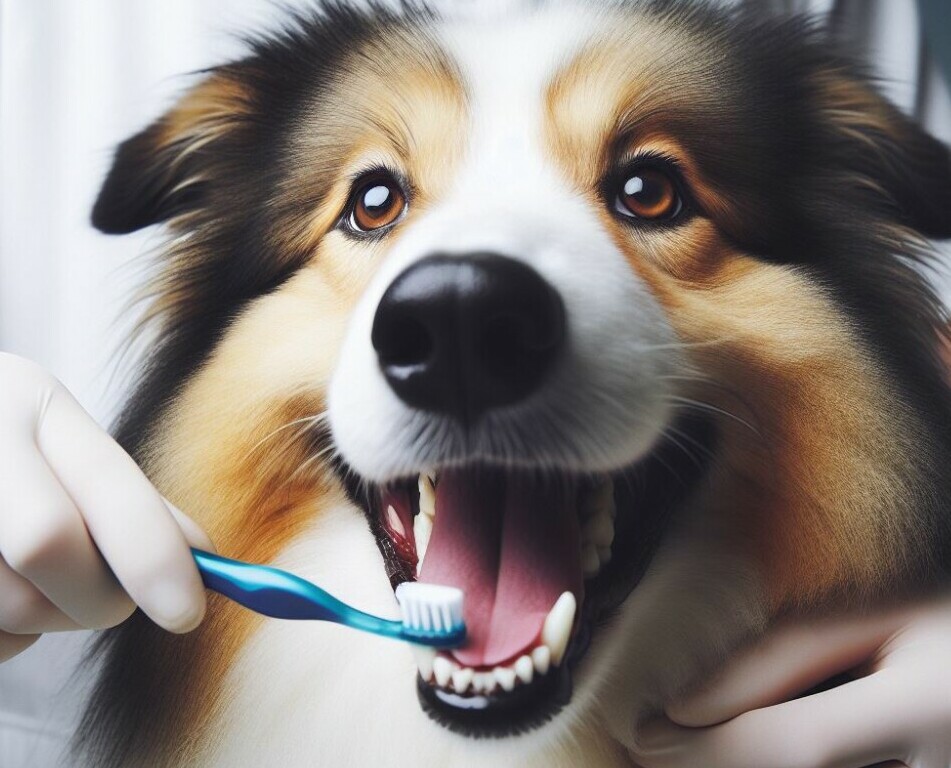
[{"left": 635, "top": 669, "right": 915, "bottom": 768}]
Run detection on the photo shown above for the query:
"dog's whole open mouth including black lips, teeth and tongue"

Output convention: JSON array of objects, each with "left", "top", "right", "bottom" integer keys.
[{"left": 342, "top": 414, "right": 713, "bottom": 736}]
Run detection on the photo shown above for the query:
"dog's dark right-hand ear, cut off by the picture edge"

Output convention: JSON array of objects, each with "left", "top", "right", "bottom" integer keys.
[{"left": 817, "top": 67, "right": 951, "bottom": 238}]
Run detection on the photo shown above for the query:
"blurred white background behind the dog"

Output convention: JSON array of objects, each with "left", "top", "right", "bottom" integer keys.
[{"left": 0, "top": 0, "right": 951, "bottom": 768}]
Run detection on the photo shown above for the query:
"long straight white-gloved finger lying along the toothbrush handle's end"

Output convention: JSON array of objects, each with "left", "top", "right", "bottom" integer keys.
[{"left": 37, "top": 391, "right": 205, "bottom": 632}]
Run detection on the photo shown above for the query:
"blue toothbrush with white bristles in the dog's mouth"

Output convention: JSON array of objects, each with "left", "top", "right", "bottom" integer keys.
[{"left": 192, "top": 549, "right": 466, "bottom": 648}]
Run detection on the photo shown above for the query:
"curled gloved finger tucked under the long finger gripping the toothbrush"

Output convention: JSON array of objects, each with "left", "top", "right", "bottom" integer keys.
[{"left": 0, "top": 438, "right": 135, "bottom": 631}]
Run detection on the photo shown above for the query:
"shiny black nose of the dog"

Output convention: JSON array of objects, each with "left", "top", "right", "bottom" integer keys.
[{"left": 372, "top": 253, "right": 565, "bottom": 423}]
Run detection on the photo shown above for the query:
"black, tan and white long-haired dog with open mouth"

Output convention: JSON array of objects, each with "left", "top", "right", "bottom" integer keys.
[{"left": 76, "top": 2, "right": 951, "bottom": 766}]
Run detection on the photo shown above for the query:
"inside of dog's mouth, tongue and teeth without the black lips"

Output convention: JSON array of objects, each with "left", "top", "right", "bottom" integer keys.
[{"left": 381, "top": 468, "right": 615, "bottom": 684}]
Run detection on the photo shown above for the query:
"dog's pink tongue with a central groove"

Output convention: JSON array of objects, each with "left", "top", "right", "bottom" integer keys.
[{"left": 419, "top": 470, "right": 584, "bottom": 667}]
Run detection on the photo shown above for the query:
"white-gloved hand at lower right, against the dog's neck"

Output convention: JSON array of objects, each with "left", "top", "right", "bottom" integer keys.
[{"left": 634, "top": 597, "right": 951, "bottom": 768}]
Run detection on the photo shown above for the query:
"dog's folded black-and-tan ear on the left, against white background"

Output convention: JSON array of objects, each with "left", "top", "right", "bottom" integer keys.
[{"left": 92, "top": 70, "right": 249, "bottom": 234}]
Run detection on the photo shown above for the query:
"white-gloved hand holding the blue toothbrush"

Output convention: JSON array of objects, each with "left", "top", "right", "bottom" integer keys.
[{"left": 0, "top": 352, "right": 213, "bottom": 661}]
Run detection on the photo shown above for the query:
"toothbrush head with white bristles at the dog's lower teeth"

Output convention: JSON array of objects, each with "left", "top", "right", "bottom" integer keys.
[{"left": 396, "top": 581, "right": 466, "bottom": 648}]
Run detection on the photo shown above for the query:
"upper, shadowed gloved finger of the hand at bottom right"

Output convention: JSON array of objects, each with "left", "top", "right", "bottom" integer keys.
[{"left": 667, "top": 613, "right": 901, "bottom": 728}]
